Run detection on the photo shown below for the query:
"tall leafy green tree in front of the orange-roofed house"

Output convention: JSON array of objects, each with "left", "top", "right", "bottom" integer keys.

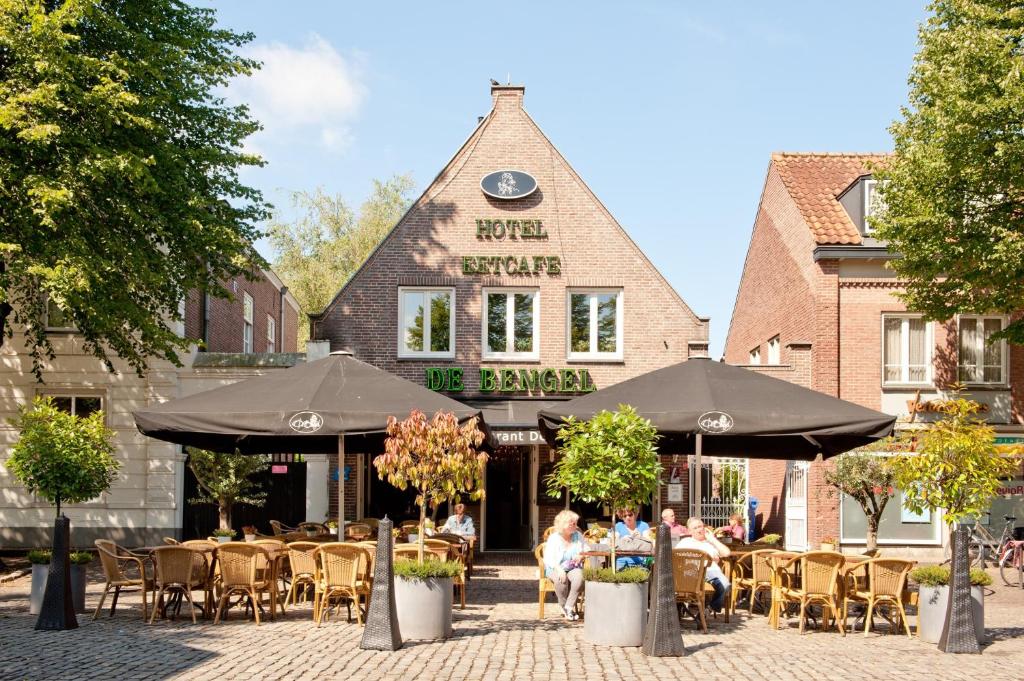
[{"left": 872, "top": 0, "right": 1024, "bottom": 343}]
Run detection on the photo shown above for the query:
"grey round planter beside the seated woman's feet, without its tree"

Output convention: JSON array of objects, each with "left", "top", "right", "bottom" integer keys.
[{"left": 583, "top": 582, "right": 648, "bottom": 646}]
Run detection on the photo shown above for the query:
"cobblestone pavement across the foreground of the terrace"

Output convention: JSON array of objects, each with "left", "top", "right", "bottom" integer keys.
[{"left": 0, "top": 561, "right": 1024, "bottom": 681}]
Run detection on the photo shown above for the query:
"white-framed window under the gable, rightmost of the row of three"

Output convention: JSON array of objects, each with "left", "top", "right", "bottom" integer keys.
[{"left": 565, "top": 289, "right": 623, "bottom": 361}]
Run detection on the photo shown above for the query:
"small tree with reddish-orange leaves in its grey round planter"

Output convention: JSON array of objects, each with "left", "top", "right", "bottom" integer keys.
[{"left": 374, "top": 410, "right": 487, "bottom": 639}]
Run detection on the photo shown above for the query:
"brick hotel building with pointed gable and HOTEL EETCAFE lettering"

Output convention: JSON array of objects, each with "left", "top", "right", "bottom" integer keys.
[{"left": 310, "top": 85, "right": 708, "bottom": 549}]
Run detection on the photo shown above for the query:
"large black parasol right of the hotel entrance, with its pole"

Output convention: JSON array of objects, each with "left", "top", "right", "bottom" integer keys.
[{"left": 538, "top": 358, "right": 896, "bottom": 514}]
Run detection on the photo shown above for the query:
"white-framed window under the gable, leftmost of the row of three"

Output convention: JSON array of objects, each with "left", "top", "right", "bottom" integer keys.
[{"left": 398, "top": 287, "right": 455, "bottom": 358}]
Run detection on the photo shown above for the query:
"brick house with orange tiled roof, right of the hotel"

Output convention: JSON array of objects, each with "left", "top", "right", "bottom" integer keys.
[{"left": 724, "top": 154, "right": 1024, "bottom": 553}]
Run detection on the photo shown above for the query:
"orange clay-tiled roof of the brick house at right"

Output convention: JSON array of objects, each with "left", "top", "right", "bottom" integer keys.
[{"left": 771, "top": 152, "right": 888, "bottom": 244}]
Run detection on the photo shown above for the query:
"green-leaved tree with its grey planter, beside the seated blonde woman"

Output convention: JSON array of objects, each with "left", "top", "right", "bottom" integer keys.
[{"left": 547, "top": 405, "right": 662, "bottom": 646}]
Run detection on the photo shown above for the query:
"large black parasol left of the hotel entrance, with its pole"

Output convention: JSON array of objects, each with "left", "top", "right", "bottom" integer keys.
[{"left": 134, "top": 352, "right": 486, "bottom": 539}]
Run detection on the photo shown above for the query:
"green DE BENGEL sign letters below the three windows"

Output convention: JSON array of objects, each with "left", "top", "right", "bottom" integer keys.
[{"left": 426, "top": 367, "right": 597, "bottom": 395}]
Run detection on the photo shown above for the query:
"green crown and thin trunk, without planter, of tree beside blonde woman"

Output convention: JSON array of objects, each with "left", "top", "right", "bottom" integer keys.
[{"left": 547, "top": 405, "right": 662, "bottom": 567}]
